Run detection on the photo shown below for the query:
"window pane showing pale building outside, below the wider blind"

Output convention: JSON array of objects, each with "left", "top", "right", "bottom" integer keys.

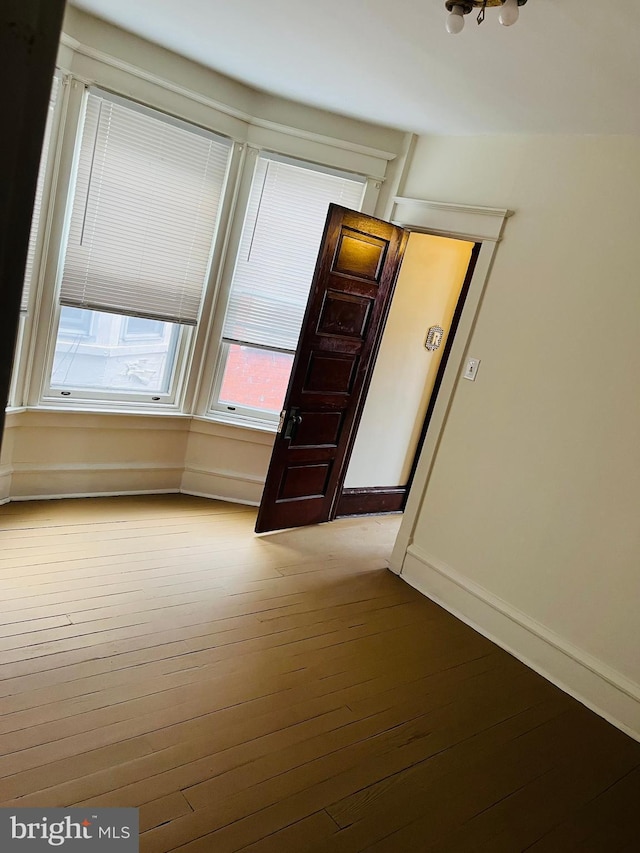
[{"left": 51, "top": 307, "right": 180, "bottom": 394}]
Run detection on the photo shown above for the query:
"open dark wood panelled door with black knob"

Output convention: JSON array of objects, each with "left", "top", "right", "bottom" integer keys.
[{"left": 256, "top": 205, "right": 408, "bottom": 533}]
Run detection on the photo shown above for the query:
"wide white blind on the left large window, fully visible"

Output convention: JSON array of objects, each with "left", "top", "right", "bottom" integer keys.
[{"left": 60, "top": 90, "right": 231, "bottom": 325}]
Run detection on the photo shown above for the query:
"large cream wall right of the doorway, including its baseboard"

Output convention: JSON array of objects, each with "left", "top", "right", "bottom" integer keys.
[{"left": 401, "top": 136, "right": 640, "bottom": 734}]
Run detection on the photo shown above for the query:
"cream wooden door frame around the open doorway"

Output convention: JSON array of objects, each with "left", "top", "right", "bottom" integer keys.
[{"left": 385, "top": 196, "right": 513, "bottom": 575}]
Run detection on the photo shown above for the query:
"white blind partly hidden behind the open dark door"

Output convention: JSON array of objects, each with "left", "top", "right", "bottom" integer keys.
[{"left": 223, "top": 154, "right": 365, "bottom": 351}]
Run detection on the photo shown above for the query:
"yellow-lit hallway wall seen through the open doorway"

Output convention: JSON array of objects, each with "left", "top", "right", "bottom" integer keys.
[{"left": 345, "top": 232, "right": 473, "bottom": 488}]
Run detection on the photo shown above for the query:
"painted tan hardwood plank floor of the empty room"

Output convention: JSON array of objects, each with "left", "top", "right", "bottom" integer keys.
[{"left": 0, "top": 496, "right": 640, "bottom": 853}]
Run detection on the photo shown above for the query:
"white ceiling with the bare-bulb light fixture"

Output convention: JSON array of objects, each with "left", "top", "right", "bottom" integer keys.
[{"left": 71, "top": 0, "right": 640, "bottom": 134}]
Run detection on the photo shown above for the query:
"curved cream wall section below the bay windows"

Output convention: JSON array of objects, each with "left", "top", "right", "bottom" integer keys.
[{"left": 0, "top": 410, "right": 274, "bottom": 504}]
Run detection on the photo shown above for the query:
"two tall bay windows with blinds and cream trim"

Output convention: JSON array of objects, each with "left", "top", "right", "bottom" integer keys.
[{"left": 15, "top": 59, "right": 380, "bottom": 429}]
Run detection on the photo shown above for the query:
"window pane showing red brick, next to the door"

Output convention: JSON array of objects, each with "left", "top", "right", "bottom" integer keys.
[{"left": 220, "top": 344, "right": 293, "bottom": 412}]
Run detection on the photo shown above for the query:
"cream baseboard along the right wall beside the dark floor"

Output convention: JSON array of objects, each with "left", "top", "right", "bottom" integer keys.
[{"left": 400, "top": 544, "right": 640, "bottom": 740}]
